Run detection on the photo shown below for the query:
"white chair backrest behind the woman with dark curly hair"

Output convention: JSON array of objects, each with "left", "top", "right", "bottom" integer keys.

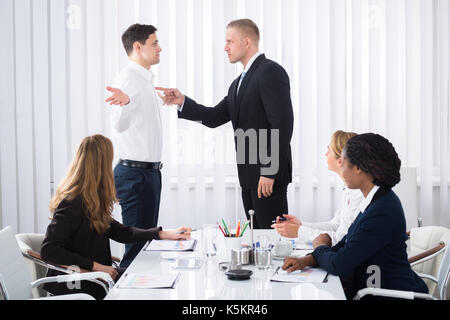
[{"left": 409, "top": 226, "right": 450, "bottom": 296}]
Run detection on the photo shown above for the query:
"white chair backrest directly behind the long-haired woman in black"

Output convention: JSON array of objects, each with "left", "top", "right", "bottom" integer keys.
[{"left": 16, "top": 233, "right": 47, "bottom": 298}]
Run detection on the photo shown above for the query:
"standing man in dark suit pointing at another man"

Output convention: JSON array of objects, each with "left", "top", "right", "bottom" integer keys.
[{"left": 155, "top": 19, "right": 294, "bottom": 229}]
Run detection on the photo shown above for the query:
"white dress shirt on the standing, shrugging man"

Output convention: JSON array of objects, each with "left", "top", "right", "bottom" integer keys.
[{"left": 111, "top": 61, "right": 162, "bottom": 162}]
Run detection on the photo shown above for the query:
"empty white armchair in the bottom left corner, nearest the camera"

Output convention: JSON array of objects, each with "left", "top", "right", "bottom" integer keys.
[{"left": 0, "top": 227, "right": 114, "bottom": 300}]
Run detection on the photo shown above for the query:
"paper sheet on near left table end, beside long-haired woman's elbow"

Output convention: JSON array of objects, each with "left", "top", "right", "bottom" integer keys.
[{"left": 118, "top": 273, "right": 180, "bottom": 289}]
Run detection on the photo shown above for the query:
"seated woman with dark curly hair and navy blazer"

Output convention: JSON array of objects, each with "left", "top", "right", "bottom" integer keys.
[{"left": 282, "top": 133, "right": 428, "bottom": 299}]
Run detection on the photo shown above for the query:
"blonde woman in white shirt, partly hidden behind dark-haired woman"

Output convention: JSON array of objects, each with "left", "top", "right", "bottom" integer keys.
[{"left": 272, "top": 130, "right": 364, "bottom": 245}]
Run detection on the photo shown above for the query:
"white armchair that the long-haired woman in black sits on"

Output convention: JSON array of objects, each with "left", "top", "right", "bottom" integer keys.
[{"left": 16, "top": 233, "right": 120, "bottom": 298}]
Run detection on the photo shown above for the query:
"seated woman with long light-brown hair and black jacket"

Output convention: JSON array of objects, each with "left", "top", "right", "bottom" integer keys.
[{"left": 41, "top": 135, "right": 191, "bottom": 299}]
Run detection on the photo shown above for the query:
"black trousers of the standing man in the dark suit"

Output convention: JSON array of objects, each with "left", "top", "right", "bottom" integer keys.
[{"left": 242, "top": 183, "right": 288, "bottom": 229}]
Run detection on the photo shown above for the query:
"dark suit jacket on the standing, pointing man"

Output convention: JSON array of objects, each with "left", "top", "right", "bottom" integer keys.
[{"left": 178, "top": 54, "right": 294, "bottom": 189}]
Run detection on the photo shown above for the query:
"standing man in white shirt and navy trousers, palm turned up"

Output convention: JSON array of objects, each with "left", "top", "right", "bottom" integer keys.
[{"left": 106, "top": 24, "right": 162, "bottom": 268}]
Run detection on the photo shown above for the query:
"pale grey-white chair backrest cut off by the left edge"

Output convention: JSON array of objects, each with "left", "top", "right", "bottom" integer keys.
[{"left": 0, "top": 227, "right": 32, "bottom": 300}]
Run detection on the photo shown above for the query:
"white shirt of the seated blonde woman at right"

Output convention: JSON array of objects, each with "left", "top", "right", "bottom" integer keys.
[{"left": 298, "top": 182, "right": 364, "bottom": 246}]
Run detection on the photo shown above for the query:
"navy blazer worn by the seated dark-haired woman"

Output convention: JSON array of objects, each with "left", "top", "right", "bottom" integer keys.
[{"left": 312, "top": 188, "right": 428, "bottom": 297}]
